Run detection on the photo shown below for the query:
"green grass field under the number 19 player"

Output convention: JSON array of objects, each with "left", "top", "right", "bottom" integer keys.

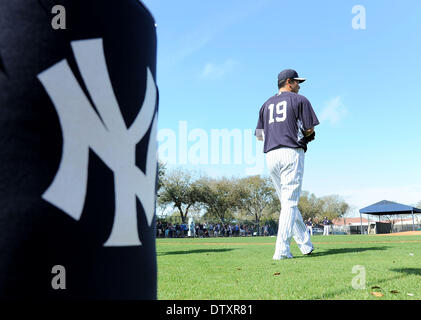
[{"left": 157, "top": 235, "right": 421, "bottom": 300}]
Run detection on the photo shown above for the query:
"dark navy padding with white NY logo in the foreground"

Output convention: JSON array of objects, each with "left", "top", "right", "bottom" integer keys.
[{"left": 0, "top": 0, "right": 158, "bottom": 299}]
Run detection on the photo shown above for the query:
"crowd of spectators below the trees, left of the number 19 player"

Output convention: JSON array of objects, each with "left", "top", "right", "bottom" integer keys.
[{"left": 156, "top": 221, "right": 274, "bottom": 238}]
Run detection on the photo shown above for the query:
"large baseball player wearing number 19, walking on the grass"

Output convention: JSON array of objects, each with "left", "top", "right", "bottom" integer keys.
[{"left": 255, "top": 69, "right": 319, "bottom": 260}]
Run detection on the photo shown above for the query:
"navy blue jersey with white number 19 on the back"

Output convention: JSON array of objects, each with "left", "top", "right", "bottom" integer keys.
[{"left": 255, "top": 91, "right": 319, "bottom": 153}]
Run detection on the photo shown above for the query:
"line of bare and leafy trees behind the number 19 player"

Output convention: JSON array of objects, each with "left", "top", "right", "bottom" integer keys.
[{"left": 157, "top": 163, "right": 350, "bottom": 225}]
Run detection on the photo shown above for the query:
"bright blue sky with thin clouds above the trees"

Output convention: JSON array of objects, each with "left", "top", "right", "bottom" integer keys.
[{"left": 143, "top": 0, "right": 421, "bottom": 215}]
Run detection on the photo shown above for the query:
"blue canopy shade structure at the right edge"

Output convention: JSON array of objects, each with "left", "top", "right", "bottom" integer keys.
[{"left": 360, "top": 200, "right": 421, "bottom": 234}]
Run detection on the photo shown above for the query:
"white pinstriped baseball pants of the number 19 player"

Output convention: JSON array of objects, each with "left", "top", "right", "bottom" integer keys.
[{"left": 266, "top": 148, "right": 313, "bottom": 260}]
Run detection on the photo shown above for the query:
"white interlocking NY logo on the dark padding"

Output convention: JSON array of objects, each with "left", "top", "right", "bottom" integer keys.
[{"left": 38, "top": 39, "right": 157, "bottom": 246}]
